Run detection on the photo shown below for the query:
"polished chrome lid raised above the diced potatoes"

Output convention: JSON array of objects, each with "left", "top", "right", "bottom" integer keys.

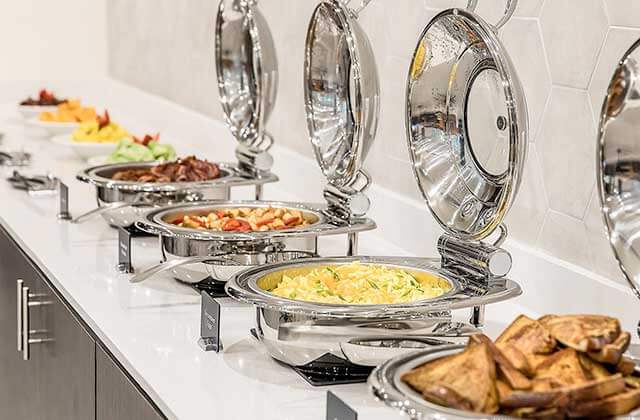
[{"left": 304, "top": 0, "right": 380, "bottom": 192}]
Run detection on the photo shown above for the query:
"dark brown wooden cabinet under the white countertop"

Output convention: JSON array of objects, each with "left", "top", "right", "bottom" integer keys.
[{"left": 0, "top": 227, "right": 164, "bottom": 420}]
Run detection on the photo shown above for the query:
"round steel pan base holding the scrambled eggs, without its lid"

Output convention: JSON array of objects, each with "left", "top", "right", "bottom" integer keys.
[{"left": 226, "top": 257, "right": 521, "bottom": 366}]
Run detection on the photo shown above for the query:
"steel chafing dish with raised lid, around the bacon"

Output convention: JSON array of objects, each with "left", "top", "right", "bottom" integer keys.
[{"left": 72, "top": 0, "right": 278, "bottom": 226}]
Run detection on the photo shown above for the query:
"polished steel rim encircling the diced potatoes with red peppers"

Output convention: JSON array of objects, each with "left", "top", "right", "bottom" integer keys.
[{"left": 136, "top": 200, "right": 376, "bottom": 242}]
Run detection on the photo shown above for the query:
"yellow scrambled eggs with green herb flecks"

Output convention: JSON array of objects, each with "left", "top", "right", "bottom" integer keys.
[{"left": 271, "top": 262, "right": 451, "bottom": 305}]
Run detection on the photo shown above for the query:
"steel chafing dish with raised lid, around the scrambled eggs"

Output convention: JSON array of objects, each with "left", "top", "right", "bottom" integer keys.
[{"left": 226, "top": 1, "right": 528, "bottom": 366}]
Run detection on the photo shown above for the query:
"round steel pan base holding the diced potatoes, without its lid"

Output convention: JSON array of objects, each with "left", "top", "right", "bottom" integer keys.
[{"left": 131, "top": 201, "right": 376, "bottom": 283}]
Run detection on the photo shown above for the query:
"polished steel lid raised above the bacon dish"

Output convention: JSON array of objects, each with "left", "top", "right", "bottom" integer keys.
[{"left": 215, "top": 0, "right": 278, "bottom": 151}]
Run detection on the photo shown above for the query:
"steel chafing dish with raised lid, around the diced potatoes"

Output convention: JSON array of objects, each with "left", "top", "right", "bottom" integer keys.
[{"left": 131, "top": 0, "right": 379, "bottom": 283}]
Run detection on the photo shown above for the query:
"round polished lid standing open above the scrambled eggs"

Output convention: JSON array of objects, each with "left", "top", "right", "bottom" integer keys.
[{"left": 406, "top": 0, "right": 528, "bottom": 240}]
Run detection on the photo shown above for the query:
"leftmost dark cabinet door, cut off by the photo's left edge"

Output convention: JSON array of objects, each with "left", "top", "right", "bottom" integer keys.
[{"left": 0, "top": 227, "right": 37, "bottom": 419}]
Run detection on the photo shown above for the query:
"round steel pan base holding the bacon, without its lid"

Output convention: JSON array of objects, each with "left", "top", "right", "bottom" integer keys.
[{"left": 74, "top": 162, "right": 278, "bottom": 226}]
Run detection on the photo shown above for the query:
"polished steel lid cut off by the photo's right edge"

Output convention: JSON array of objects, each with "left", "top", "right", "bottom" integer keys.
[{"left": 596, "top": 40, "right": 640, "bottom": 310}]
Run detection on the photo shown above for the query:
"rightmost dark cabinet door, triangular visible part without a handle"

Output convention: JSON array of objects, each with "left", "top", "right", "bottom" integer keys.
[{"left": 96, "top": 346, "right": 165, "bottom": 420}]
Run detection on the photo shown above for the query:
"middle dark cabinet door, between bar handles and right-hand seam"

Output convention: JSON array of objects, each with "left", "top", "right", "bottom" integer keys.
[{"left": 30, "top": 272, "right": 95, "bottom": 420}]
